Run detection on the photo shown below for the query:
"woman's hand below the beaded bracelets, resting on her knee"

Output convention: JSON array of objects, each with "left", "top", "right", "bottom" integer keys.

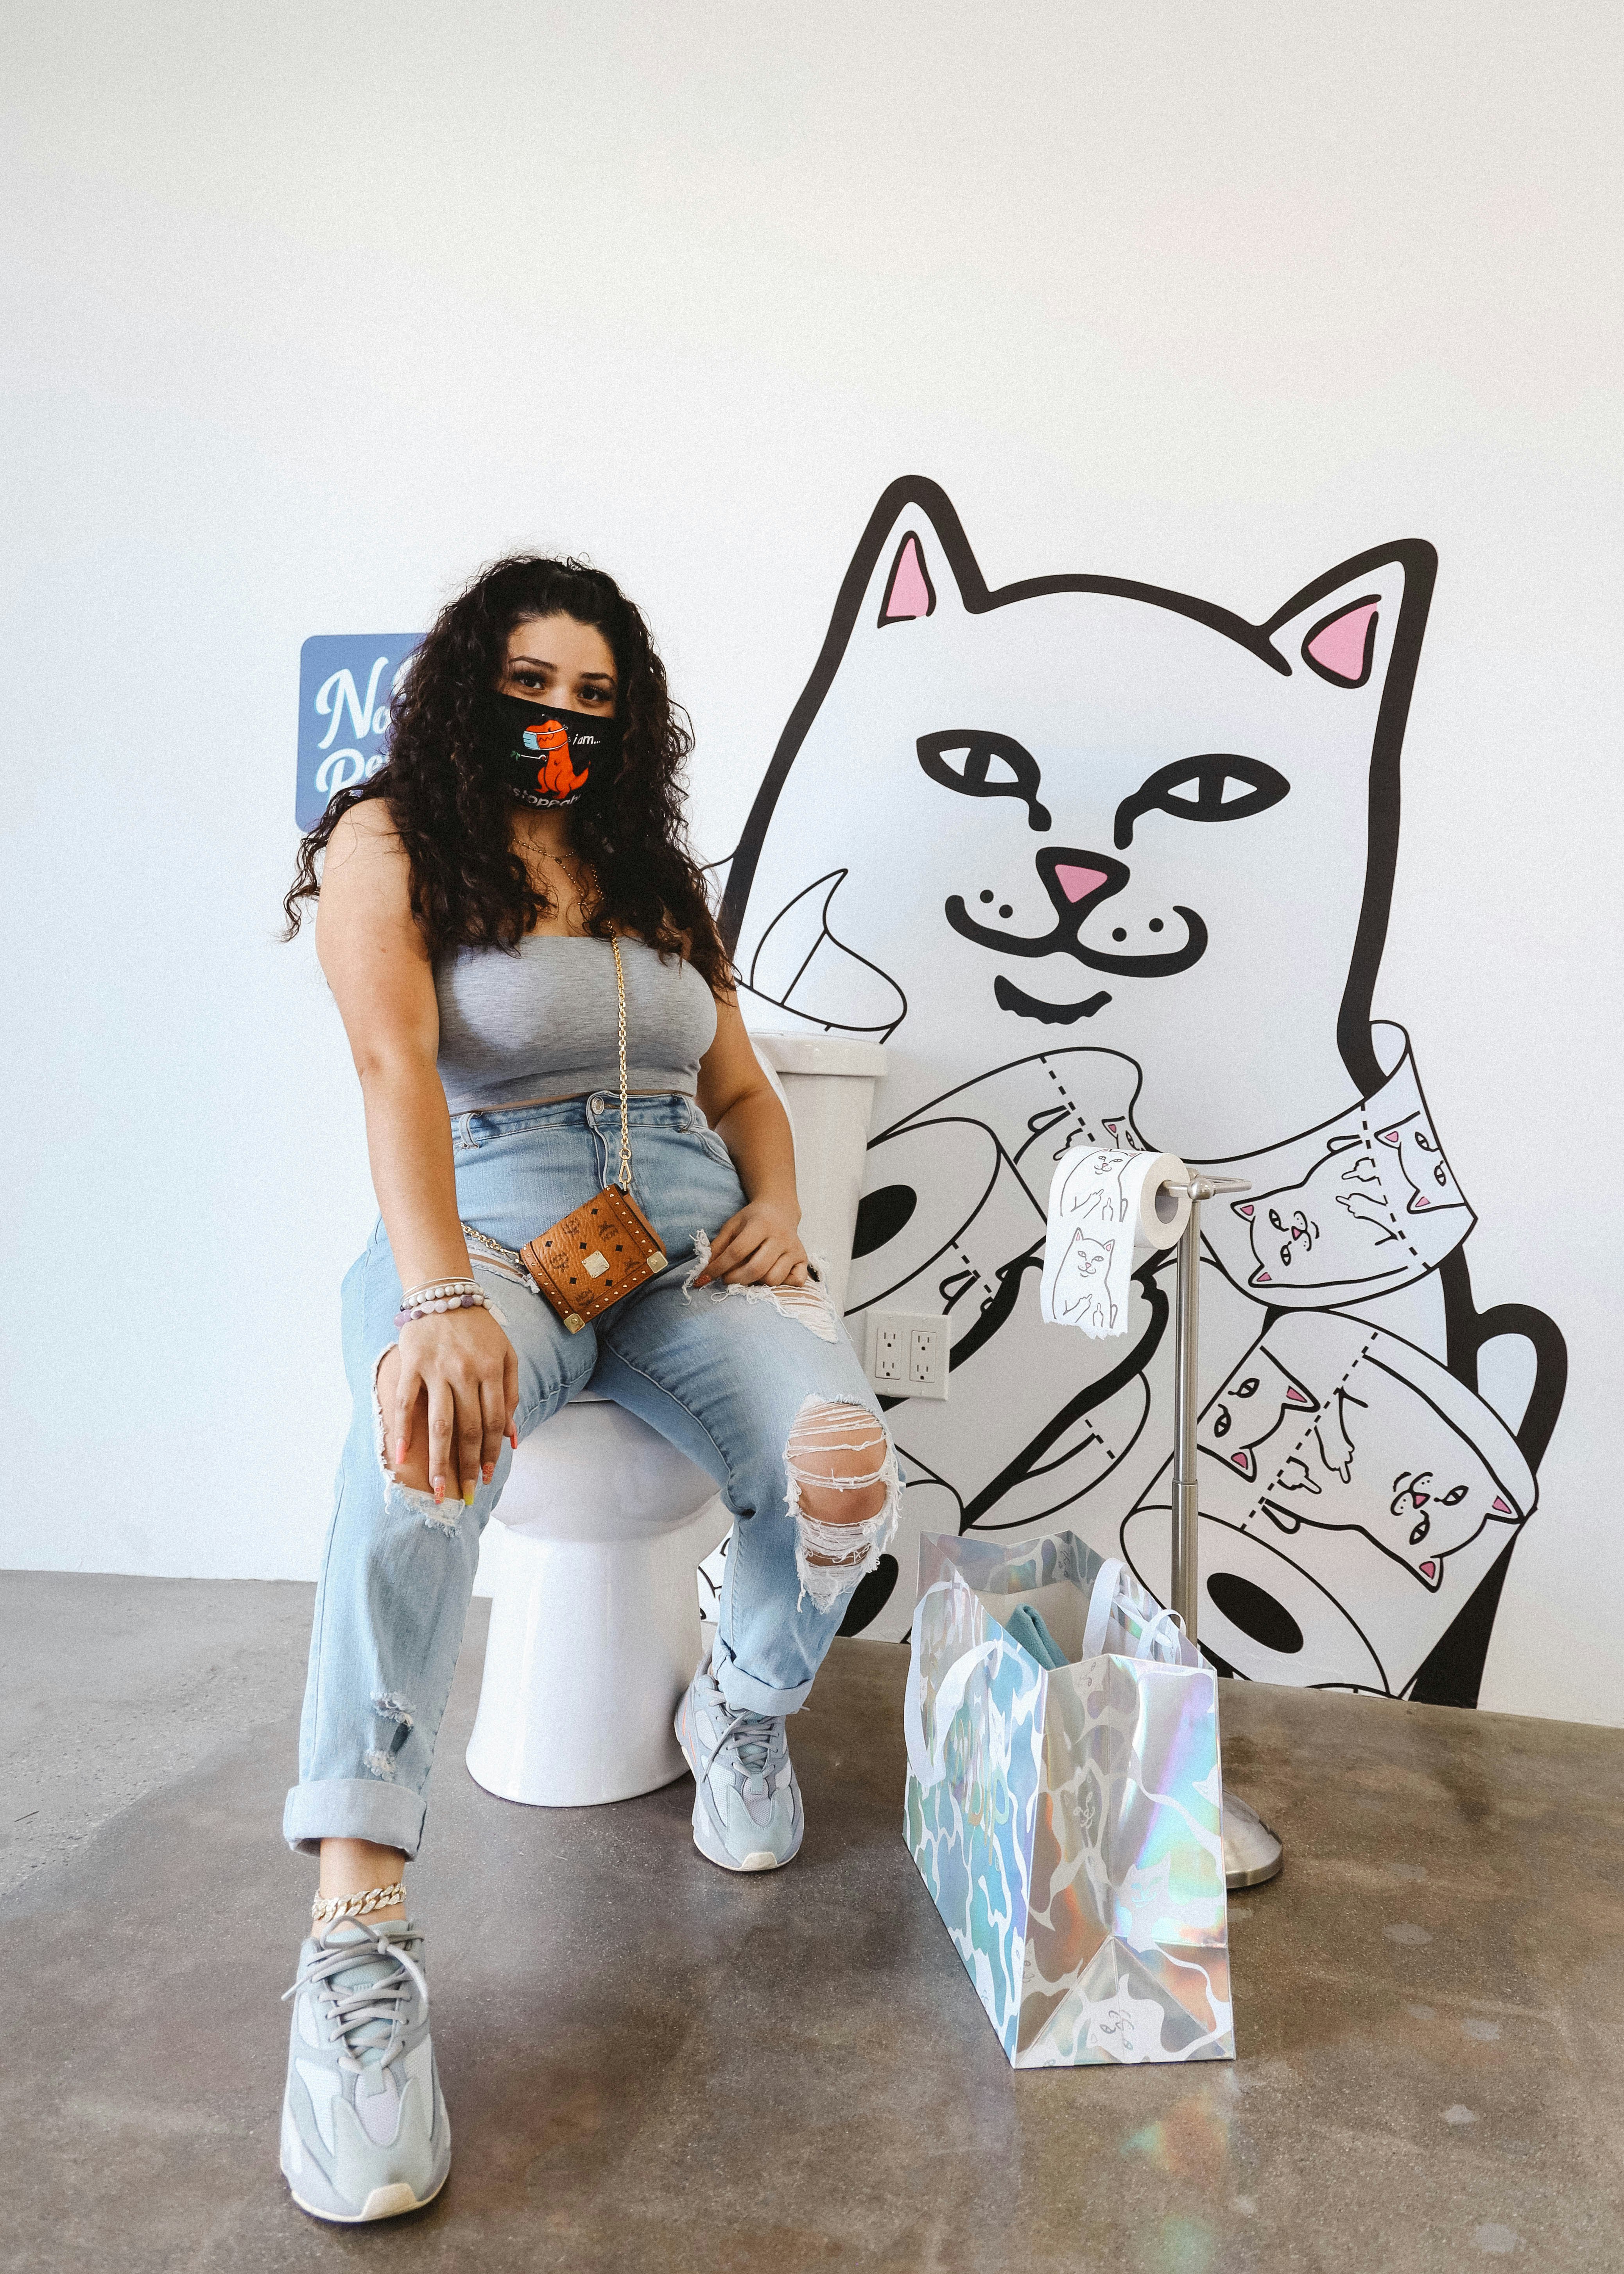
[{"left": 389, "top": 1310, "right": 518, "bottom": 1501}]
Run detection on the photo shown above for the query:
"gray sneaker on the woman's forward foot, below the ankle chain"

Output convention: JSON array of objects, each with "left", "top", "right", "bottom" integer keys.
[{"left": 282, "top": 1919, "right": 450, "bottom": 2226}]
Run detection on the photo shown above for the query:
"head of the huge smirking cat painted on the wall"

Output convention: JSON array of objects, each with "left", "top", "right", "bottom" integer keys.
[{"left": 726, "top": 482, "right": 1433, "bottom": 1157}]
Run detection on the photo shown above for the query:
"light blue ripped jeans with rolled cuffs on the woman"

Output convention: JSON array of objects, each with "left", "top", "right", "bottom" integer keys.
[{"left": 282, "top": 1096, "right": 901, "bottom": 1856}]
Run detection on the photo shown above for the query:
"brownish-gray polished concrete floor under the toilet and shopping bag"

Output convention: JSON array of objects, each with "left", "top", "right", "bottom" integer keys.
[{"left": 0, "top": 1574, "right": 1624, "bottom": 2274}]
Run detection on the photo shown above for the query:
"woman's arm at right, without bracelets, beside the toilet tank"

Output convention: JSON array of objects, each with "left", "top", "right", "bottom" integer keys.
[{"left": 694, "top": 1001, "right": 807, "bottom": 1287}]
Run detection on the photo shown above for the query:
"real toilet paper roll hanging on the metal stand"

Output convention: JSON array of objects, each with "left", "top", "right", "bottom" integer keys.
[{"left": 1040, "top": 1146, "right": 1190, "bottom": 1340}]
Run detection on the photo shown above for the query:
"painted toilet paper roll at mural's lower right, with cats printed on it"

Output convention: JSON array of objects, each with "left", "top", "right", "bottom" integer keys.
[{"left": 1121, "top": 1312, "right": 1535, "bottom": 1694}]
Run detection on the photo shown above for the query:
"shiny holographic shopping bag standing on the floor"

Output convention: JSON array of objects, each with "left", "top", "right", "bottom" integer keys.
[{"left": 905, "top": 1533, "right": 1235, "bottom": 2070}]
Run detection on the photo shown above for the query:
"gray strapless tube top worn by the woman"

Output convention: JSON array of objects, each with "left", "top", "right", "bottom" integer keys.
[{"left": 434, "top": 933, "right": 717, "bottom": 1114}]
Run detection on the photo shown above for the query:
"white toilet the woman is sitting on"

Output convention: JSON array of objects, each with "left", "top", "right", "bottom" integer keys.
[{"left": 466, "top": 1032, "right": 885, "bottom": 1808}]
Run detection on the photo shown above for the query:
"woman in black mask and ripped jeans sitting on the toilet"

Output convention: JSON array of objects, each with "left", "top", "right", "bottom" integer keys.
[{"left": 272, "top": 557, "right": 898, "bottom": 2222}]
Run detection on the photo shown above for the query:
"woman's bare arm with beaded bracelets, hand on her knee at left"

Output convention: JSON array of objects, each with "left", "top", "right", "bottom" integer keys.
[{"left": 316, "top": 798, "right": 518, "bottom": 1501}]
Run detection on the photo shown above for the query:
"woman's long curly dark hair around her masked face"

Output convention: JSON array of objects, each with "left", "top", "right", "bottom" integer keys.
[{"left": 282, "top": 552, "right": 735, "bottom": 996}]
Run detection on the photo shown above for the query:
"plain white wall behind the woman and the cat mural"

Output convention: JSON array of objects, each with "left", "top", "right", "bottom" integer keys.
[{"left": 0, "top": 0, "right": 1624, "bottom": 1722}]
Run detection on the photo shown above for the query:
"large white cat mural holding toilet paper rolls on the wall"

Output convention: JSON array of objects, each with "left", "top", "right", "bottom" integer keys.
[{"left": 723, "top": 477, "right": 1565, "bottom": 1703}]
